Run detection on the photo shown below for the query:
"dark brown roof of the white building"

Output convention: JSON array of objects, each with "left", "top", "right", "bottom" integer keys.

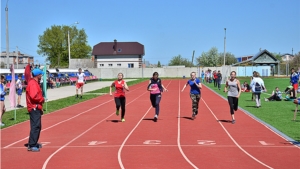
[{"left": 92, "top": 42, "right": 145, "bottom": 56}]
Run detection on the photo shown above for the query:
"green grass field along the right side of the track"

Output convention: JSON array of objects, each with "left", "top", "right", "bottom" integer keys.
[{"left": 204, "top": 78, "right": 300, "bottom": 141}]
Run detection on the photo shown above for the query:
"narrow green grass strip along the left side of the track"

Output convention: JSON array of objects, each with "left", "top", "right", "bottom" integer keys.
[{"left": 2, "top": 79, "right": 146, "bottom": 128}]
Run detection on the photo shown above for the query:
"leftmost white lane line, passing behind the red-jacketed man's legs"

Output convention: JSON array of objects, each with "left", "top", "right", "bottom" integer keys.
[{"left": 3, "top": 86, "right": 144, "bottom": 148}]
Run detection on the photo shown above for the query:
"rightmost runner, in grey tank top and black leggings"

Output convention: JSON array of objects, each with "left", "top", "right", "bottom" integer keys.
[{"left": 224, "top": 71, "right": 241, "bottom": 124}]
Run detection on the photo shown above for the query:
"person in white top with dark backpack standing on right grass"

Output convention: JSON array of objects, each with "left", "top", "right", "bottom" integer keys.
[{"left": 250, "top": 72, "right": 267, "bottom": 108}]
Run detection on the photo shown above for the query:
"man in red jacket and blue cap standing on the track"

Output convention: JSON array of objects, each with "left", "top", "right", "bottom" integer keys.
[{"left": 26, "top": 69, "right": 45, "bottom": 152}]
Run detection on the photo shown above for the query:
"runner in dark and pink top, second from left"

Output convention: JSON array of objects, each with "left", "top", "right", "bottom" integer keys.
[{"left": 147, "top": 72, "right": 168, "bottom": 122}]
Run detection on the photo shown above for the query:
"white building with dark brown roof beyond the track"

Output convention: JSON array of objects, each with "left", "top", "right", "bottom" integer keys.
[{"left": 92, "top": 40, "right": 145, "bottom": 68}]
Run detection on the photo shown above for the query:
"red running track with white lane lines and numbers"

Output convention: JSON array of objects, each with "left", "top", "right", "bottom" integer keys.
[{"left": 1, "top": 80, "right": 300, "bottom": 169}]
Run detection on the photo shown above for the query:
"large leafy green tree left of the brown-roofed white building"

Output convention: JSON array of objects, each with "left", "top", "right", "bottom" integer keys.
[{"left": 37, "top": 25, "right": 92, "bottom": 67}]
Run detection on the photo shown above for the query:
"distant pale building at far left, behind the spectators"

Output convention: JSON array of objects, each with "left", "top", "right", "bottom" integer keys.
[{"left": 1, "top": 51, "right": 34, "bottom": 65}]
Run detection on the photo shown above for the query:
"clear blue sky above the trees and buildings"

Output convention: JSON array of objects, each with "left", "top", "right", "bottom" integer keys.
[{"left": 1, "top": 0, "right": 300, "bottom": 64}]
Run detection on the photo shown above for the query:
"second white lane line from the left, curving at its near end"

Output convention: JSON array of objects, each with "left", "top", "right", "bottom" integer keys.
[{"left": 42, "top": 92, "right": 148, "bottom": 169}]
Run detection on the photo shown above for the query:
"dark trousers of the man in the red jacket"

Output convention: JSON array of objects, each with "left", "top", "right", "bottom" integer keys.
[{"left": 28, "top": 110, "right": 42, "bottom": 147}]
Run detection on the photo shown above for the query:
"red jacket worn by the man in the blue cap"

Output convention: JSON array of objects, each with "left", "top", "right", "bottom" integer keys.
[{"left": 26, "top": 79, "right": 45, "bottom": 112}]
